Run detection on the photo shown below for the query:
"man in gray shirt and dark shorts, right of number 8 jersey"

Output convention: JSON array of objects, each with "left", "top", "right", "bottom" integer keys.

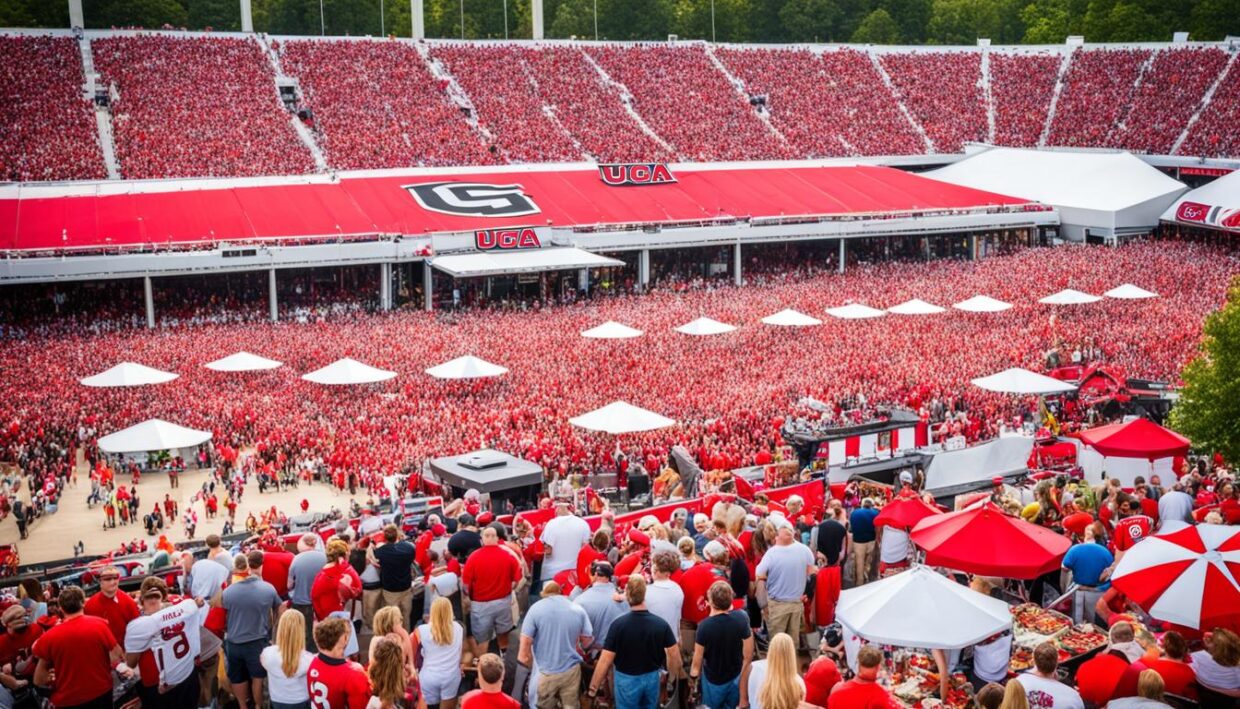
[{"left": 223, "top": 552, "right": 281, "bottom": 707}]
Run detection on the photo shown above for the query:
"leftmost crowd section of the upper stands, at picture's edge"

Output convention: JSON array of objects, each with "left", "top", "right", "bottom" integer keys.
[{"left": 0, "top": 35, "right": 107, "bottom": 181}]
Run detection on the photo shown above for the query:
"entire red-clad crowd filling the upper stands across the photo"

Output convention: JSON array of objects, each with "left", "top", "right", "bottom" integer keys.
[{"left": 0, "top": 33, "right": 1240, "bottom": 180}]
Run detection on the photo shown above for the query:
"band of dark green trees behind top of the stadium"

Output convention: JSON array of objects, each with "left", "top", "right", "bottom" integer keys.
[{"left": 0, "top": 0, "right": 1240, "bottom": 45}]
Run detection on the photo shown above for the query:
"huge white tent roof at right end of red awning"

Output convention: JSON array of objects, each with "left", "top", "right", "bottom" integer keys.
[{"left": 923, "top": 148, "right": 1188, "bottom": 242}]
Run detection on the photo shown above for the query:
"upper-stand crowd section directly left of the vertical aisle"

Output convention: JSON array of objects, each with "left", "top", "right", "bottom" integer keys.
[{"left": 879, "top": 52, "right": 988, "bottom": 152}]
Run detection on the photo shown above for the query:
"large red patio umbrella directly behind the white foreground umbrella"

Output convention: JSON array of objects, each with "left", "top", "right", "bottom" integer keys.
[{"left": 910, "top": 501, "right": 1071, "bottom": 579}]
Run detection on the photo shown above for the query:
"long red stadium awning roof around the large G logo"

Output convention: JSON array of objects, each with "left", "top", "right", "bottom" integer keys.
[{"left": 0, "top": 166, "right": 1029, "bottom": 250}]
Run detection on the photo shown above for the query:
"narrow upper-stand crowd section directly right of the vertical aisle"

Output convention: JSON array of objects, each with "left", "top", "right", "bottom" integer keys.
[{"left": 991, "top": 52, "right": 1063, "bottom": 148}]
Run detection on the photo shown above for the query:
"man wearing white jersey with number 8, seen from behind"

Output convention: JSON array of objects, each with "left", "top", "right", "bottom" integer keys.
[{"left": 125, "top": 585, "right": 205, "bottom": 709}]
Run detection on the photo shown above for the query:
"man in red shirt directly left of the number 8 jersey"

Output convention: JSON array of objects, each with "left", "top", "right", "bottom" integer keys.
[{"left": 33, "top": 586, "right": 134, "bottom": 709}]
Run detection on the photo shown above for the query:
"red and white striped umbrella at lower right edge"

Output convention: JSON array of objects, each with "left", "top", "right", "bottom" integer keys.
[{"left": 1111, "top": 524, "right": 1240, "bottom": 630}]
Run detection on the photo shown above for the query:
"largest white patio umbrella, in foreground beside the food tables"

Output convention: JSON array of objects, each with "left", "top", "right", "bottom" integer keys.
[{"left": 836, "top": 564, "right": 1012, "bottom": 650}]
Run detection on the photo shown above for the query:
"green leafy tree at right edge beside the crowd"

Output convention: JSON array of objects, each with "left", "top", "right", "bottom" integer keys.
[{"left": 1169, "top": 278, "right": 1240, "bottom": 471}]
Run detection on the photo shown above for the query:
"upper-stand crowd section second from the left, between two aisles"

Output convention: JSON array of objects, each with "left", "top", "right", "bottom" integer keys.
[{"left": 91, "top": 35, "right": 314, "bottom": 178}]
